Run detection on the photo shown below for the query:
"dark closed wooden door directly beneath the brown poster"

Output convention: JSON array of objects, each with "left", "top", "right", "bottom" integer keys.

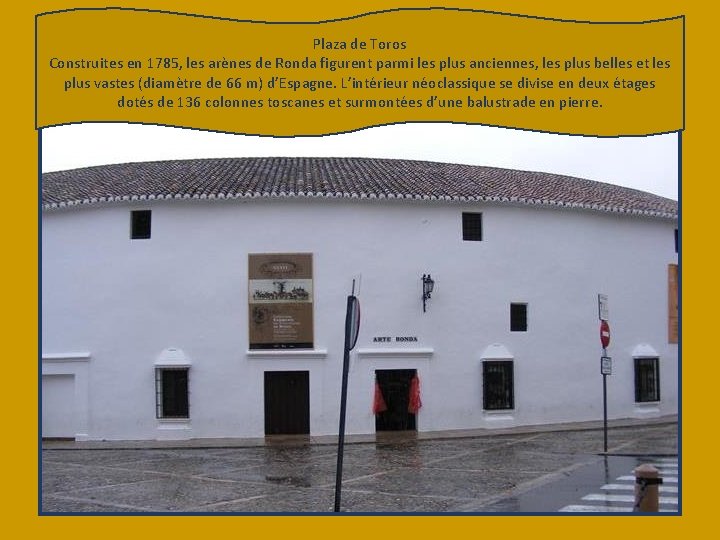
[{"left": 265, "top": 371, "right": 310, "bottom": 435}]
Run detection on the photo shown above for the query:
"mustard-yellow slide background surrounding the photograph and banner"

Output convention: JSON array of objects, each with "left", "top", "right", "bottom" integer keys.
[{"left": 11, "top": 0, "right": 704, "bottom": 539}]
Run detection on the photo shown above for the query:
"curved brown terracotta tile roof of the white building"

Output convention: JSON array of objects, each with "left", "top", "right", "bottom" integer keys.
[{"left": 42, "top": 157, "right": 678, "bottom": 219}]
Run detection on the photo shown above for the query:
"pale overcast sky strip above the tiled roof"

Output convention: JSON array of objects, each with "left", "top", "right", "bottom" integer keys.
[{"left": 42, "top": 124, "right": 678, "bottom": 199}]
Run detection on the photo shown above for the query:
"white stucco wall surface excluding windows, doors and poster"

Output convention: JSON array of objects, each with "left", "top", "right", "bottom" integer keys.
[{"left": 42, "top": 199, "right": 678, "bottom": 439}]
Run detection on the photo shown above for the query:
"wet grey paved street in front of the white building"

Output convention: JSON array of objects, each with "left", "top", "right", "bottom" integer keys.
[{"left": 40, "top": 420, "right": 678, "bottom": 514}]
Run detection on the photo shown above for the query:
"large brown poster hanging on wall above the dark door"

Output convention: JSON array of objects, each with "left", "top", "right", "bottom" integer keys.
[{"left": 248, "top": 253, "right": 313, "bottom": 349}]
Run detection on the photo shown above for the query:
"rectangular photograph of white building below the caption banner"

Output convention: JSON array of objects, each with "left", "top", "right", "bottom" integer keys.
[{"left": 40, "top": 122, "right": 681, "bottom": 515}]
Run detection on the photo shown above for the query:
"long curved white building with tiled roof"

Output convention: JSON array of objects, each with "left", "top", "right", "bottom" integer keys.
[{"left": 41, "top": 158, "right": 679, "bottom": 440}]
